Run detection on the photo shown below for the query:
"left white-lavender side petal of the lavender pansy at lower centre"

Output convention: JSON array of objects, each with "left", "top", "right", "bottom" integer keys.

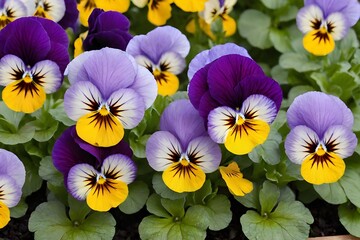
[{"left": 146, "top": 131, "right": 182, "bottom": 171}]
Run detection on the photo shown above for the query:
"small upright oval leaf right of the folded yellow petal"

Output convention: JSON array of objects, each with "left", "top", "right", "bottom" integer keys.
[{"left": 259, "top": 181, "right": 280, "bottom": 215}]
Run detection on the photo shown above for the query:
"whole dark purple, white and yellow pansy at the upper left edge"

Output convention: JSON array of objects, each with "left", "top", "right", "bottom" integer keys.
[{"left": 0, "top": 17, "right": 69, "bottom": 113}]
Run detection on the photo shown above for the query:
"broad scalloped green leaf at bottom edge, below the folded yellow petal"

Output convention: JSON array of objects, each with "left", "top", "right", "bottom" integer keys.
[{"left": 240, "top": 201, "right": 313, "bottom": 240}]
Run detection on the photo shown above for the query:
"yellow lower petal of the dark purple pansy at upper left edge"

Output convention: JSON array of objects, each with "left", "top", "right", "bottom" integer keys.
[{"left": 2, "top": 80, "right": 46, "bottom": 113}]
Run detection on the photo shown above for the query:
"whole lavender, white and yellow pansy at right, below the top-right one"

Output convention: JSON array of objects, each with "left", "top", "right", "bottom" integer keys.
[{"left": 285, "top": 92, "right": 357, "bottom": 184}]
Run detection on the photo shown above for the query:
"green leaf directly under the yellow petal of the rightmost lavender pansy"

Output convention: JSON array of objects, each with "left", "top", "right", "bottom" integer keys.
[{"left": 314, "top": 182, "right": 347, "bottom": 204}]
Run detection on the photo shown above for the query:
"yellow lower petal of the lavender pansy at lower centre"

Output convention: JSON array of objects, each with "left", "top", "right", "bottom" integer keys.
[{"left": 162, "top": 160, "right": 206, "bottom": 193}]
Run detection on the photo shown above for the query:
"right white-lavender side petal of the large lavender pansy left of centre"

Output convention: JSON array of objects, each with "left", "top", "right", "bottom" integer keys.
[{"left": 107, "top": 89, "right": 145, "bottom": 129}]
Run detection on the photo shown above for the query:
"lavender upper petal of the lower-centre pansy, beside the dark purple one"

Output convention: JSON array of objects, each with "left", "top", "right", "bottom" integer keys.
[{"left": 160, "top": 99, "right": 207, "bottom": 149}]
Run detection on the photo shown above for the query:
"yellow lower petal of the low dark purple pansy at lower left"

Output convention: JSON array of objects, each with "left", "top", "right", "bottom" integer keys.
[{"left": 86, "top": 180, "right": 129, "bottom": 212}]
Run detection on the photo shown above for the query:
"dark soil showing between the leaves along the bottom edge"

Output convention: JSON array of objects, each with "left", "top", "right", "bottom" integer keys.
[{"left": 0, "top": 186, "right": 348, "bottom": 240}]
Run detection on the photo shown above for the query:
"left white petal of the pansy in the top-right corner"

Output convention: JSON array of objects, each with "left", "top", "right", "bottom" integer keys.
[{"left": 296, "top": 5, "right": 324, "bottom": 33}]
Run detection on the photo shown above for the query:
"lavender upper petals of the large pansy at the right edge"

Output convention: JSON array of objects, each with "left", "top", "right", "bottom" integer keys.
[{"left": 287, "top": 92, "right": 354, "bottom": 138}]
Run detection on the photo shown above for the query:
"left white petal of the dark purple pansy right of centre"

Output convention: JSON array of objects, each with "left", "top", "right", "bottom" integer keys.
[{"left": 208, "top": 107, "right": 236, "bottom": 143}]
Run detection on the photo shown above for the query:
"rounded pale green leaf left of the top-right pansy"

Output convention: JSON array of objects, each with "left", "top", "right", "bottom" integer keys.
[{"left": 238, "top": 9, "right": 272, "bottom": 49}]
